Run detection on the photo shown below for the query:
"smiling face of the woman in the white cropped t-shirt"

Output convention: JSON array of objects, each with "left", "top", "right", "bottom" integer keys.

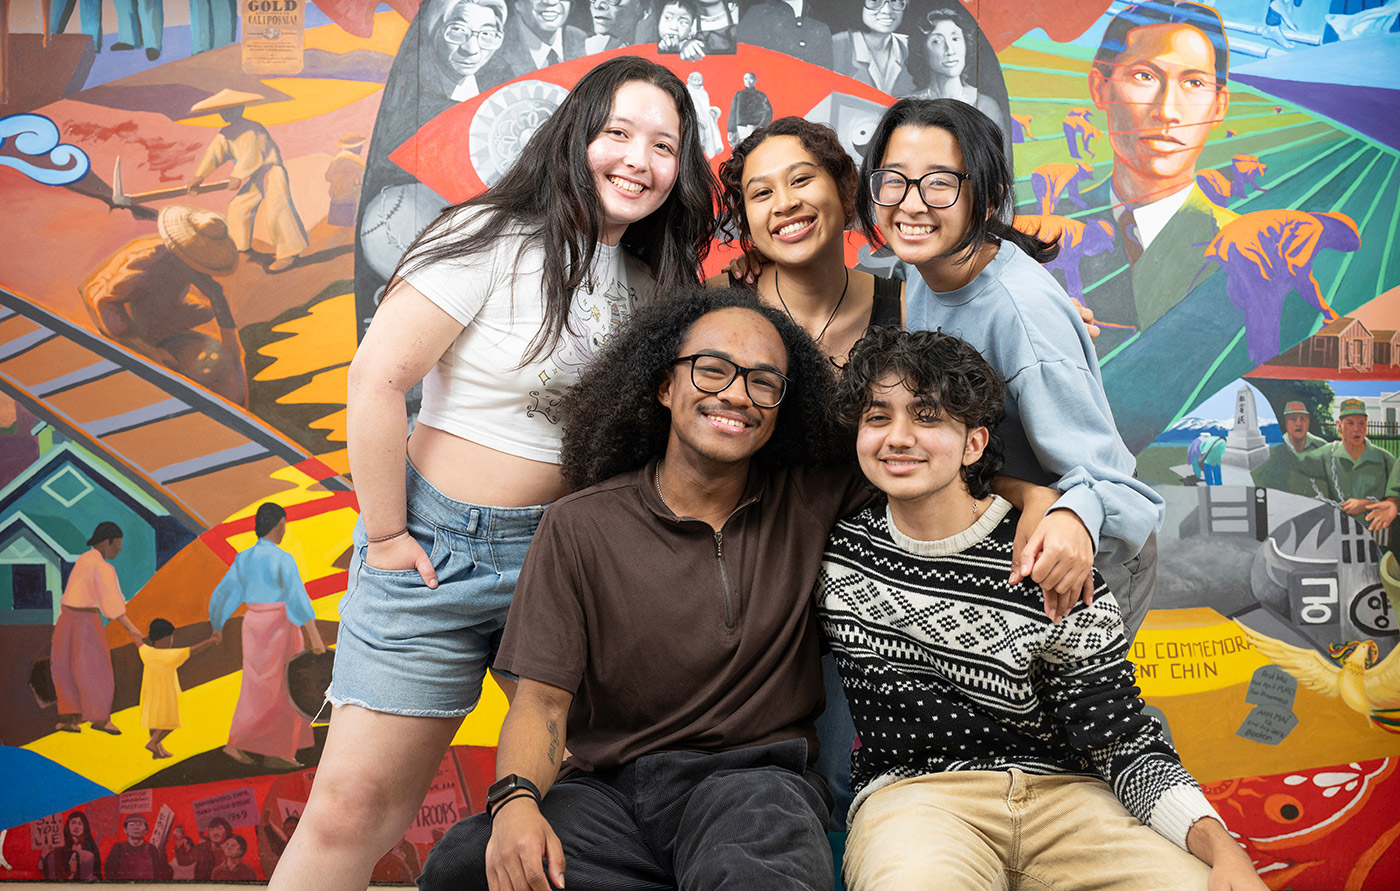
[{"left": 588, "top": 80, "right": 680, "bottom": 244}]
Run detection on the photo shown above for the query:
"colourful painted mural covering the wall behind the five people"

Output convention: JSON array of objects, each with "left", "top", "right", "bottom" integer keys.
[{"left": 0, "top": 0, "right": 1400, "bottom": 891}]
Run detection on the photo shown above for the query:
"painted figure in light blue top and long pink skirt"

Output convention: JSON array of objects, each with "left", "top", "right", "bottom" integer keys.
[{"left": 209, "top": 502, "right": 326, "bottom": 768}]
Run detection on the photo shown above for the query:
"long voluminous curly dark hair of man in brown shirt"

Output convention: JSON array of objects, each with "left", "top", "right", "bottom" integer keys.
[{"left": 560, "top": 287, "right": 854, "bottom": 489}]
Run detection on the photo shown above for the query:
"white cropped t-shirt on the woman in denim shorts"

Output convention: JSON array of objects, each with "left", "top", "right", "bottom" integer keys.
[{"left": 402, "top": 209, "right": 655, "bottom": 464}]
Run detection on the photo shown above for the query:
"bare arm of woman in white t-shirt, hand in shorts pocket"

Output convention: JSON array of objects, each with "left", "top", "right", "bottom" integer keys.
[{"left": 346, "top": 282, "right": 462, "bottom": 587}]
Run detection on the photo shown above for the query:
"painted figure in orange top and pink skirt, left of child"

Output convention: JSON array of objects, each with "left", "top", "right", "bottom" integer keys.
[{"left": 49, "top": 521, "right": 143, "bottom": 735}]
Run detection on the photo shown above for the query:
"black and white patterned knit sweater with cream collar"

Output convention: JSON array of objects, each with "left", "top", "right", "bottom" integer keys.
[{"left": 816, "top": 497, "right": 1215, "bottom": 848}]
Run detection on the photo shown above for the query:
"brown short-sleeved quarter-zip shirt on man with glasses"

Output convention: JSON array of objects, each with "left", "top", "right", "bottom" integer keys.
[{"left": 496, "top": 460, "right": 871, "bottom": 771}]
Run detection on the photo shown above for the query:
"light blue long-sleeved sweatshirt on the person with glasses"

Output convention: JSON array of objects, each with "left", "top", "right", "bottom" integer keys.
[{"left": 904, "top": 241, "right": 1165, "bottom": 566}]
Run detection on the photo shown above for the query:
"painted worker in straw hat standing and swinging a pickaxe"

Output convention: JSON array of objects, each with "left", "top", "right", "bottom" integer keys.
[{"left": 188, "top": 90, "right": 307, "bottom": 272}]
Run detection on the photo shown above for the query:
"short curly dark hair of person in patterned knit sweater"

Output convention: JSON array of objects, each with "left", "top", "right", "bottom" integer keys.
[{"left": 836, "top": 328, "right": 1007, "bottom": 499}]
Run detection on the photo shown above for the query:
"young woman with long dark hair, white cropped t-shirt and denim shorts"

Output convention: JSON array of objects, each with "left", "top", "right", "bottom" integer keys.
[{"left": 272, "top": 56, "right": 715, "bottom": 888}]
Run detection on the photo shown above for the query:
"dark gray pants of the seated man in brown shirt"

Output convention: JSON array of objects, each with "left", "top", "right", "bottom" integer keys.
[{"left": 419, "top": 740, "right": 836, "bottom": 891}]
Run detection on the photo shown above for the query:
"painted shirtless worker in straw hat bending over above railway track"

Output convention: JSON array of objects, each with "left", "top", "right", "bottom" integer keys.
[{"left": 81, "top": 205, "right": 248, "bottom": 405}]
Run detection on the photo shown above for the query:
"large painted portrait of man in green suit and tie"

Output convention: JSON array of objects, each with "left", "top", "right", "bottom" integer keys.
[{"left": 1079, "top": 0, "right": 1247, "bottom": 453}]
